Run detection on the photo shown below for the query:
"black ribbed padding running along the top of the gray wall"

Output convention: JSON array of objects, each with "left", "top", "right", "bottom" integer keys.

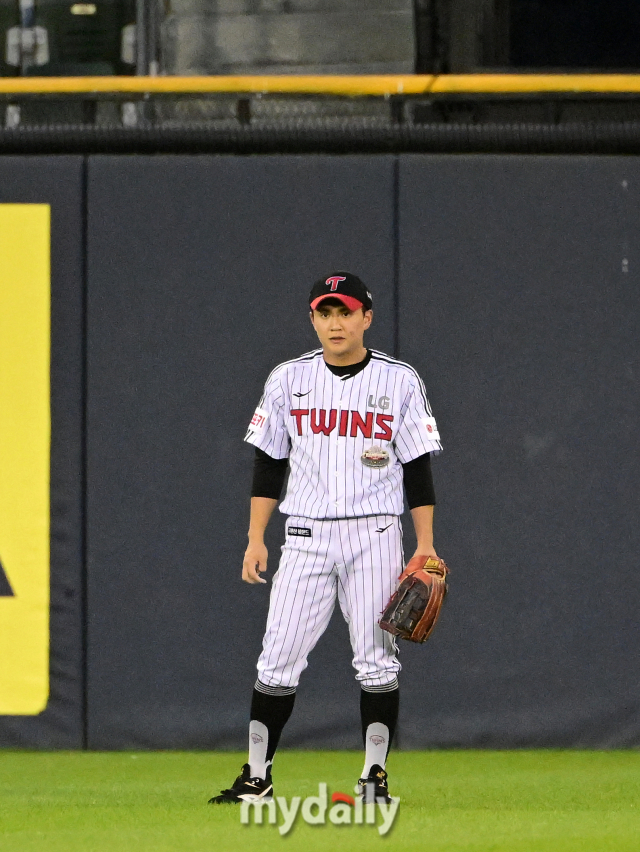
[{"left": 5, "top": 118, "right": 640, "bottom": 155}]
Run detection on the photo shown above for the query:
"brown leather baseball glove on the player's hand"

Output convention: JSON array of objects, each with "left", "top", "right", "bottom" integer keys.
[{"left": 378, "top": 556, "right": 449, "bottom": 642}]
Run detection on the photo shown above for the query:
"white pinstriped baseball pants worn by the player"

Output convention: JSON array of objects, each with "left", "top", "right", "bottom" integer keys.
[{"left": 258, "top": 515, "right": 403, "bottom": 687}]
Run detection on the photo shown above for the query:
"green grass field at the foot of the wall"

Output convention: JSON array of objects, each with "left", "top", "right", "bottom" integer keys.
[{"left": 0, "top": 751, "right": 640, "bottom": 852}]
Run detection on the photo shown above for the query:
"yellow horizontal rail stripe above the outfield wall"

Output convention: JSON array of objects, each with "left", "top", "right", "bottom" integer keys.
[{"left": 0, "top": 74, "right": 640, "bottom": 97}]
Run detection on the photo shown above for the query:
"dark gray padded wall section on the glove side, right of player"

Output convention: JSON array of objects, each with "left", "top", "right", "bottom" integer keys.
[{"left": 399, "top": 156, "right": 640, "bottom": 748}]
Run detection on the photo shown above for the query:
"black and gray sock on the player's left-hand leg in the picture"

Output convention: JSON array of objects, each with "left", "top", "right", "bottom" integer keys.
[{"left": 249, "top": 681, "right": 296, "bottom": 778}]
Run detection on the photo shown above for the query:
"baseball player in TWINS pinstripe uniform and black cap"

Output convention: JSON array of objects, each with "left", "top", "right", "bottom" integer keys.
[{"left": 210, "top": 272, "right": 441, "bottom": 803}]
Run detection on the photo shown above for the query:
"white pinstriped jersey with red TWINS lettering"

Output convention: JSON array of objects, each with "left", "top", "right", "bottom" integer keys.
[{"left": 245, "top": 349, "right": 442, "bottom": 519}]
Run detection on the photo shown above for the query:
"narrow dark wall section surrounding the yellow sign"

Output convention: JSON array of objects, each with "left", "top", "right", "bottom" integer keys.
[{"left": 0, "top": 157, "right": 84, "bottom": 748}]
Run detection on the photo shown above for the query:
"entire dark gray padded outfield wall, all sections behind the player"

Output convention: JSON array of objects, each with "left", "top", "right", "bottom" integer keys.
[{"left": 0, "top": 155, "right": 640, "bottom": 748}]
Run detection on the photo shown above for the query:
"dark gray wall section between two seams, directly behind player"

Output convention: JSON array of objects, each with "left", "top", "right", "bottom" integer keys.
[{"left": 87, "top": 156, "right": 394, "bottom": 748}]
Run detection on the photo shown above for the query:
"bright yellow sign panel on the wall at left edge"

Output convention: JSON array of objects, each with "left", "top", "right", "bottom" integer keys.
[{"left": 0, "top": 204, "right": 51, "bottom": 716}]
